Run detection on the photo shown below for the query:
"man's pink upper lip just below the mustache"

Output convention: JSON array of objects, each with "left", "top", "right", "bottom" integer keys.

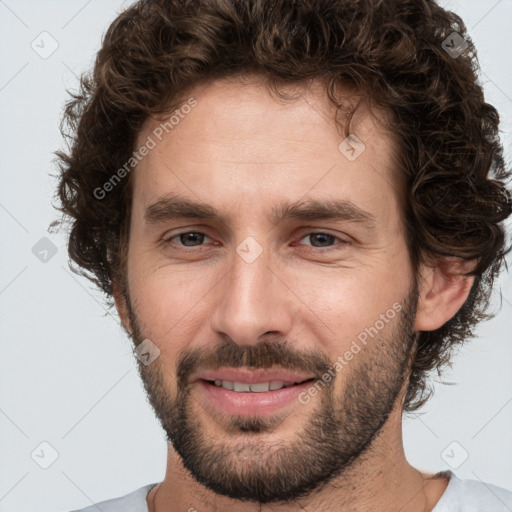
[{"left": 191, "top": 368, "right": 314, "bottom": 384}]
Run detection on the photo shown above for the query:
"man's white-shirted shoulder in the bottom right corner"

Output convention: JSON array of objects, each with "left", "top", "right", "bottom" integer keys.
[{"left": 432, "top": 471, "right": 512, "bottom": 512}]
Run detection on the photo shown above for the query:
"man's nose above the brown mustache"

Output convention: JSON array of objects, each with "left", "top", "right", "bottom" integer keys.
[{"left": 210, "top": 241, "right": 294, "bottom": 345}]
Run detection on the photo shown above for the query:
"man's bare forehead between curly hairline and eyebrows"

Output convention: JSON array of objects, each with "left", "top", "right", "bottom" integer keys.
[{"left": 133, "top": 76, "right": 404, "bottom": 226}]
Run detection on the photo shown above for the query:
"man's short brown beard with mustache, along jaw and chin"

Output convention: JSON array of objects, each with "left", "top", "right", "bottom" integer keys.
[{"left": 124, "top": 282, "right": 418, "bottom": 504}]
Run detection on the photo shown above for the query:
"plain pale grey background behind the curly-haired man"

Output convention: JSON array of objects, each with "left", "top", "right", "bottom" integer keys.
[{"left": 0, "top": 0, "right": 512, "bottom": 512}]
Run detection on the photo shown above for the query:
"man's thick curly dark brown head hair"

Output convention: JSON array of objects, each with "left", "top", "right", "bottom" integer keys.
[{"left": 52, "top": 0, "right": 512, "bottom": 412}]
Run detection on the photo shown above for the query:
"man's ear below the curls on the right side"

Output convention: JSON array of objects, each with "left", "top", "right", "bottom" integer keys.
[{"left": 414, "top": 257, "right": 476, "bottom": 331}]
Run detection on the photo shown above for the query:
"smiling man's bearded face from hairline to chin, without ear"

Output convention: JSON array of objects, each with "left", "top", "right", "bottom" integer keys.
[{"left": 118, "top": 82, "right": 417, "bottom": 503}]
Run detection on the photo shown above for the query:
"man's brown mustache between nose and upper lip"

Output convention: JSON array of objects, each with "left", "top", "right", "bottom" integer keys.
[{"left": 176, "top": 340, "right": 331, "bottom": 388}]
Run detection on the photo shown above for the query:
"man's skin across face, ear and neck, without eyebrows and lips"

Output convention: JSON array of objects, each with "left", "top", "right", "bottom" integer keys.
[{"left": 115, "top": 80, "right": 472, "bottom": 512}]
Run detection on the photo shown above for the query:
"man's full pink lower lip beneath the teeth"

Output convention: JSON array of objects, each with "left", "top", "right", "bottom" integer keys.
[{"left": 197, "top": 380, "right": 313, "bottom": 416}]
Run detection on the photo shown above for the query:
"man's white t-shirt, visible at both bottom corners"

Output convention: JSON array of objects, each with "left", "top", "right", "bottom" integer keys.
[{"left": 68, "top": 470, "right": 512, "bottom": 512}]
